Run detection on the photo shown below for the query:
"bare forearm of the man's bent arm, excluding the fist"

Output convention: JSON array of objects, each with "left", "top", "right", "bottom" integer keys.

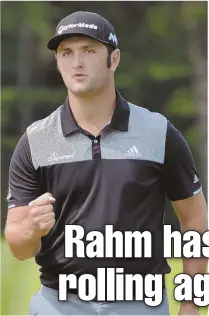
[{"left": 5, "top": 219, "right": 41, "bottom": 260}]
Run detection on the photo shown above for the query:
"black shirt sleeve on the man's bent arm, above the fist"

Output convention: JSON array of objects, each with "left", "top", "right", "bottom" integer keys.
[{"left": 7, "top": 133, "right": 41, "bottom": 209}]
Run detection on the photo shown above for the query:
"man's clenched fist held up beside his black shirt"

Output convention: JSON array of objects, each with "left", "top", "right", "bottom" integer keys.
[{"left": 28, "top": 193, "right": 55, "bottom": 238}]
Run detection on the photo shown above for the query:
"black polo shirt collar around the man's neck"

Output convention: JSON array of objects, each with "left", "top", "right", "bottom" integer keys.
[{"left": 61, "top": 90, "right": 130, "bottom": 136}]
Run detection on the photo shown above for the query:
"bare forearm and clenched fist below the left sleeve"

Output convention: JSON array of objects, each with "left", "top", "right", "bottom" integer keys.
[{"left": 5, "top": 193, "right": 55, "bottom": 260}]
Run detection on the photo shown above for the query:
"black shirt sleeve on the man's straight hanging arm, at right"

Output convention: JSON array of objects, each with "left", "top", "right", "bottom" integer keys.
[{"left": 163, "top": 121, "right": 202, "bottom": 201}]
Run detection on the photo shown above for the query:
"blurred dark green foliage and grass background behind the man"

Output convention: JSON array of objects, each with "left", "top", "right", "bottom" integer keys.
[{"left": 1, "top": 1, "right": 207, "bottom": 315}]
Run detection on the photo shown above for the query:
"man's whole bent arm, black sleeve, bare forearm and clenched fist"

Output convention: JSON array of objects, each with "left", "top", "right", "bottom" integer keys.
[{"left": 5, "top": 134, "right": 55, "bottom": 260}]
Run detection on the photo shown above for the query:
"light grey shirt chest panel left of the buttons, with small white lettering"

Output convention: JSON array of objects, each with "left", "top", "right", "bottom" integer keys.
[{"left": 27, "top": 107, "right": 91, "bottom": 169}]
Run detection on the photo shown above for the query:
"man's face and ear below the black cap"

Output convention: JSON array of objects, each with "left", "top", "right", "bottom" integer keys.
[{"left": 56, "top": 37, "right": 120, "bottom": 96}]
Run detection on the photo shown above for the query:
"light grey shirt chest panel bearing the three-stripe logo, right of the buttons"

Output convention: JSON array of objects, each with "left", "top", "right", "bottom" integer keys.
[{"left": 102, "top": 103, "right": 167, "bottom": 164}]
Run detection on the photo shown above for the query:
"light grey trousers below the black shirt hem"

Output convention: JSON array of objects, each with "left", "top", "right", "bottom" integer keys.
[{"left": 29, "top": 285, "right": 169, "bottom": 316}]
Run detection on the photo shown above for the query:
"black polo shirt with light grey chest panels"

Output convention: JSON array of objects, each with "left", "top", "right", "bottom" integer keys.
[{"left": 8, "top": 92, "right": 201, "bottom": 289}]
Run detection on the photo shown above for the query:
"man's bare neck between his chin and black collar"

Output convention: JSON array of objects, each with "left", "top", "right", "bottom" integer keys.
[{"left": 68, "top": 86, "right": 116, "bottom": 135}]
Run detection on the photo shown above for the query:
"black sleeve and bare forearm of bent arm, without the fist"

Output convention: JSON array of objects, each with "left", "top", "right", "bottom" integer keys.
[{"left": 5, "top": 133, "right": 40, "bottom": 260}]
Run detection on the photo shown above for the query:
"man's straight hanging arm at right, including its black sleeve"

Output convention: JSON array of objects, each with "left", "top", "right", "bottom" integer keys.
[{"left": 163, "top": 122, "right": 208, "bottom": 315}]
